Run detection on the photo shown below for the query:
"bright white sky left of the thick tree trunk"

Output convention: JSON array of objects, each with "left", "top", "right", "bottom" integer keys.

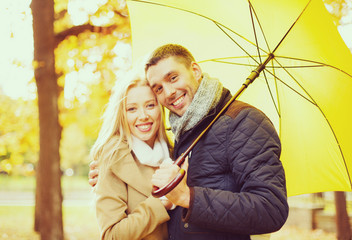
[{"left": 0, "top": 0, "right": 35, "bottom": 98}]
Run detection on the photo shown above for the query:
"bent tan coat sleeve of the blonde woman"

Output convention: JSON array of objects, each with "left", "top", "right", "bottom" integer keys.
[{"left": 95, "top": 154, "right": 169, "bottom": 240}]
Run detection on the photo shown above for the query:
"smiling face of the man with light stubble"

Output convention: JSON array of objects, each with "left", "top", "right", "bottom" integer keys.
[{"left": 147, "top": 57, "right": 202, "bottom": 116}]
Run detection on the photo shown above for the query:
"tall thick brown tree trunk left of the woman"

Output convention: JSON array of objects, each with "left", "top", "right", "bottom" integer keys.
[{"left": 31, "top": 0, "right": 63, "bottom": 240}]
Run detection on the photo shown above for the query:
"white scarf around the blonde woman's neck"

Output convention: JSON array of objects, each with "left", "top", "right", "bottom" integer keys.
[{"left": 132, "top": 136, "right": 172, "bottom": 167}]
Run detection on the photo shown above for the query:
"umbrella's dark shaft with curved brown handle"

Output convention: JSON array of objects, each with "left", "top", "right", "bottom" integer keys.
[{"left": 152, "top": 53, "right": 274, "bottom": 197}]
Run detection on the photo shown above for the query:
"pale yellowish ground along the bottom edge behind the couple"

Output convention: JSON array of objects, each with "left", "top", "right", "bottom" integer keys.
[{"left": 0, "top": 206, "right": 336, "bottom": 240}]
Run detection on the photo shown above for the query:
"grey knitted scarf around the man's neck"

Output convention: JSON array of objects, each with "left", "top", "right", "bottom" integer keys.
[{"left": 169, "top": 74, "right": 223, "bottom": 141}]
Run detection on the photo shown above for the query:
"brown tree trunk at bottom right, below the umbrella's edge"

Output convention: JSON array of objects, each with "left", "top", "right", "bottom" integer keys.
[{"left": 335, "top": 192, "right": 352, "bottom": 240}]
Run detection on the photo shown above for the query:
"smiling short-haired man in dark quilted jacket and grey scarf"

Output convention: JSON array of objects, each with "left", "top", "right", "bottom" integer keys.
[{"left": 89, "top": 44, "right": 288, "bottom": 240}]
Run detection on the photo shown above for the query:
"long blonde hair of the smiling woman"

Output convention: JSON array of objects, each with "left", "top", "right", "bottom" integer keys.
[{"left": 90, "top": 67, "right": 170, "bottom": 170}]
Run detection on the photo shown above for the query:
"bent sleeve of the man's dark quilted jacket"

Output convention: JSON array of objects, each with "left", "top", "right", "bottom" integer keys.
[{"left": 184, "top": 108, "right": 288, "bottom": 235}]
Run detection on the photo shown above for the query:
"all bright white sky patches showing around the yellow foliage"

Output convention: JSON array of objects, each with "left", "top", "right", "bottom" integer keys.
[{"left": 0, "top": 0, "right": 352, "bottom": 99}]
